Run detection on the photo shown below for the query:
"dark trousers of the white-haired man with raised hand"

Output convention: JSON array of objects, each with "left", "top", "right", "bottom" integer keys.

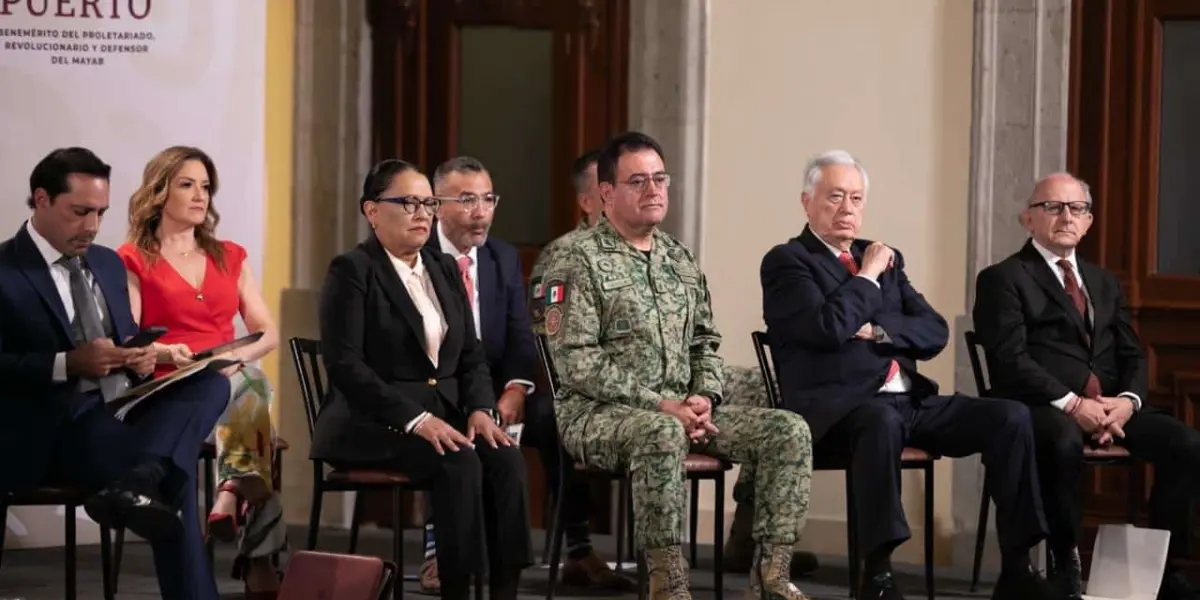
[{"left": 814, "top": 395, "right": 1046, "bottom": 553}]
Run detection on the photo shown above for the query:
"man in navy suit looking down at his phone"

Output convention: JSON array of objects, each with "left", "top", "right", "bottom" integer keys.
[{"left": 0, "top": 148, "right": 229, "bottom": 600}]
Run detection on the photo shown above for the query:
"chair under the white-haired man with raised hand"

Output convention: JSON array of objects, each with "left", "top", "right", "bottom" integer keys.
[{"left": 750, "top": 331, "right": 940, "bottom": 600}]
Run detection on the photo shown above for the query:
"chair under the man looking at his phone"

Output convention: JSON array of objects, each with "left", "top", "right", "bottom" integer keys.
[{"left": 0, "top": 486, "right": 116, "bottom": 600}]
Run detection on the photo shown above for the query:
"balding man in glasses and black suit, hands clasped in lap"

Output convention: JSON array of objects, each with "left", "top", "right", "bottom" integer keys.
[{"left": 973, "top": 173, "right": 1200, "bottom": 599}]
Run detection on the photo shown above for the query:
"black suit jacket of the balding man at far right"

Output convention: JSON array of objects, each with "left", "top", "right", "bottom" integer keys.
[{"left": 972, "top": 241, "right": 1148, "bottom": 406}]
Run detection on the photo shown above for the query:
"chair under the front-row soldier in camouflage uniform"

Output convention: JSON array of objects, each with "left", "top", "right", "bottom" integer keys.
[{"left": 536, "top": 335, "right": 733, "bottom": 600}]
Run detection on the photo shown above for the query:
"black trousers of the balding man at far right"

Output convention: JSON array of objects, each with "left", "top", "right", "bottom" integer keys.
[{"left": 1030, "top": 406, "right": 1200, "bottom": 558}]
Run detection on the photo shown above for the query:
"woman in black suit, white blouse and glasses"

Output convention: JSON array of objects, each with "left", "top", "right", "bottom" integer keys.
[{"left": 312, "top": 158, "right": 532, "bottom": 600}]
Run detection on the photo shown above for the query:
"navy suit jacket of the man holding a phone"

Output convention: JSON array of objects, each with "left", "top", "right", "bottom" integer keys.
[{"left": 0, "top": 226, "right": 138, "bottom": 491}]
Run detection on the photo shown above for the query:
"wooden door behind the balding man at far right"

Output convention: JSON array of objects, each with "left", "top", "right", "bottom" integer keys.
[{"left": 1068, "top": 0, "right": 1200, "bottom": 574}]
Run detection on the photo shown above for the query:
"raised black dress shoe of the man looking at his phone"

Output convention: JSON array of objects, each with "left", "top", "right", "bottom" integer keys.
[{"left": 83, "top": 485, "right": 184, "bottom": 542}]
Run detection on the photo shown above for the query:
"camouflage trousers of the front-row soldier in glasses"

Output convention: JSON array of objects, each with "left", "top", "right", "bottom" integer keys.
[{"left": 554, "top": 391, "right": 812, "bottom": 550}]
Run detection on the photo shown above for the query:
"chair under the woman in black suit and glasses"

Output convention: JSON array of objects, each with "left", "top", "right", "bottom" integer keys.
[{"left": 288, "top": 337, "right": 484, "bottom": 600}]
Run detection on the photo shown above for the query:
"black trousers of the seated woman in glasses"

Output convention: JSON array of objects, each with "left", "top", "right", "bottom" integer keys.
[{"left": 357, "top": 424, "right": 533, "bottom": 588}]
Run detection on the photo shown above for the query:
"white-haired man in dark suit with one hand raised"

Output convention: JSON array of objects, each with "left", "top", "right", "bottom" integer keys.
[{"left": 761, "top": 151, "right": 1055, "bottom": 600}]
